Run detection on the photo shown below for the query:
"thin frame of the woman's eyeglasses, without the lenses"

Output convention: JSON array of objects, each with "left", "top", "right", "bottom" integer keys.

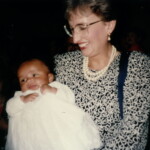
[{"left": 64, "top": 20, "right": 103, "bottom": 37}]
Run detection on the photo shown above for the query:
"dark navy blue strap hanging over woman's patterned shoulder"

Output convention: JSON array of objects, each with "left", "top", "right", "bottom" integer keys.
[{"left": 118, "top": 52, "right": 130, "bottom": 119}]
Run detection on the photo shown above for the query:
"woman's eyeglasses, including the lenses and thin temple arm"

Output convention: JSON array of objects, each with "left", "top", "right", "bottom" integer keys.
[{"left": 64, "top": 20, "right": 102, "bottom": 37}]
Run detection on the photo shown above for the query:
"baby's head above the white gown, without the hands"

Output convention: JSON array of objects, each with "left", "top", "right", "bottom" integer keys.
[{"left": 18, "top": 60, "right": 52, "bottom": 92}]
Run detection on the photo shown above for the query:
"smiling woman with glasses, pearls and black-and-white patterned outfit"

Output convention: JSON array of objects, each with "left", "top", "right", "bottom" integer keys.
[{"left": 55, "top": 0, "right": 150, "bottom": 150}]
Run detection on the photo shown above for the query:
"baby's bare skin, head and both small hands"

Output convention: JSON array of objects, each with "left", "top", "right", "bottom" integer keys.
[{"left": 18, "top": 59, "right": 57, "bottom": 102}]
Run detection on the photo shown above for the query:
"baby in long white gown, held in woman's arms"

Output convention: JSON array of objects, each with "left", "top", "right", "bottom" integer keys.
[{"left": 6, "top": 59, "right": 102, "bottom": 150}]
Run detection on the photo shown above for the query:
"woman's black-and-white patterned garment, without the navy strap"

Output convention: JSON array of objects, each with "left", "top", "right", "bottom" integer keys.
[{"left": 55, "top": 51, "right": 150, "bottom": 150}]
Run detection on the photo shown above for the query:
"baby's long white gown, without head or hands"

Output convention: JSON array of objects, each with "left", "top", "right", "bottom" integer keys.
[{"left": 6, "top": 81, "right": 102, "bottom": 150}]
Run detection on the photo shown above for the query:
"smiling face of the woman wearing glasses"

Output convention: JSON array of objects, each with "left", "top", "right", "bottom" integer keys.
[{"left": 69, "top": 11, "right": 110, "bottom": 57}]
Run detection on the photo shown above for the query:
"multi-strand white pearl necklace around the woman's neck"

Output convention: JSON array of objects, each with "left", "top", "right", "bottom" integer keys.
[{"left": 83, "top": 46, "right": 116, "bottom": 81}]
